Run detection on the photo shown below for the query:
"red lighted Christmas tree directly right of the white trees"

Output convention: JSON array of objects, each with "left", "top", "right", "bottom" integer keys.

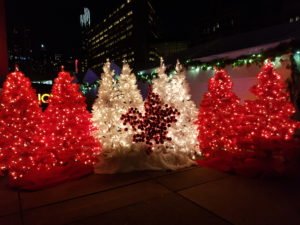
[{"left": 198, "top": 70, "right": 241, "bottom": 156}]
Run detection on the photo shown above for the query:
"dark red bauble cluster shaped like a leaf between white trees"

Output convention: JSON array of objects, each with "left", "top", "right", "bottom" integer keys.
[{"left": 121, "top": 90, "right": 180, "bottom": 146}]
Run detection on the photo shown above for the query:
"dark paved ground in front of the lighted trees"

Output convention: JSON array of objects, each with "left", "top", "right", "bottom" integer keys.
[{"left": 0, "top": 167, "right": 300, "bottom": 225}]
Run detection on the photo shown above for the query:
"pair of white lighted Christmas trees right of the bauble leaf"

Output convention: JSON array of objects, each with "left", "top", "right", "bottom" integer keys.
[{"left": 153, "top": 58, "right": 200, "bottom": 159}]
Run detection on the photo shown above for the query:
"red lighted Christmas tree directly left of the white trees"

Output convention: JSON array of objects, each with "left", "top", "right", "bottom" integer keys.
[{"left": 44, "top": 68, "right": 101, "bottom": 166}]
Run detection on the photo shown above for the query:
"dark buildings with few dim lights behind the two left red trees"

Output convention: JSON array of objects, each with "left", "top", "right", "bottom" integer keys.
[{"left": 8, "top": 25, "right": 76, "bottom": 80}]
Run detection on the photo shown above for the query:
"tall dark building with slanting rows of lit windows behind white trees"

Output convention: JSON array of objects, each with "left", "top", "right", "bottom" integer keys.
[{"left": 81, "top": 0, "right": 159, "bottom": 71}]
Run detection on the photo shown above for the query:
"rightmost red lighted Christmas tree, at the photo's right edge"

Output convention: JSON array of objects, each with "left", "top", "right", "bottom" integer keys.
[{"left": 242, "top": 62, "right": 297, "bottom": 145}]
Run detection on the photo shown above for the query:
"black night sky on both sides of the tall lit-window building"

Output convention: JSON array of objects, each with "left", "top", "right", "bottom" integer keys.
[{"left": 6, "top": 0, "right": 288, "bottom": 55}]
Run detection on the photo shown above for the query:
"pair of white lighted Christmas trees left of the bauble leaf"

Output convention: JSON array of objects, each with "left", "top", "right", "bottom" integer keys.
[{"left": 93, "top": 61, "right": 143, "bottom": 157}]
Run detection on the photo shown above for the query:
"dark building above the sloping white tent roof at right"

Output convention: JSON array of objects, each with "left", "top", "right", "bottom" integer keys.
[{"left": 190, "top": 0, "right": 300, "bottom": 45}]
